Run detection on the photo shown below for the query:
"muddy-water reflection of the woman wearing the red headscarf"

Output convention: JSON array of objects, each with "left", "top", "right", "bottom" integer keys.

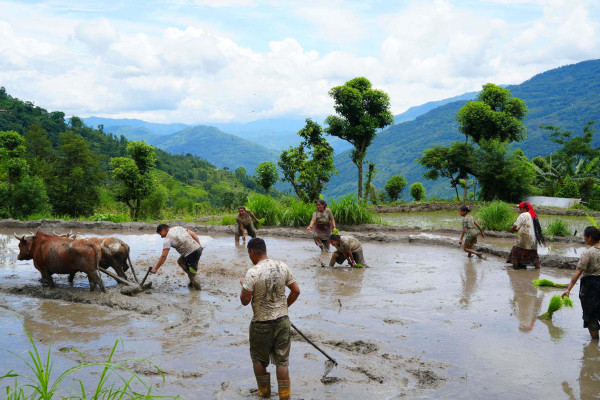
[{"left": 507, "top": 268, "right": 544, "bottom": 332}]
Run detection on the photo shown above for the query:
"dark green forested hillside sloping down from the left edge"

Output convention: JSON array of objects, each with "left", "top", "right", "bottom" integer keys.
[{"left": 0, "top": 88, "right": 262, "bottom": 217}]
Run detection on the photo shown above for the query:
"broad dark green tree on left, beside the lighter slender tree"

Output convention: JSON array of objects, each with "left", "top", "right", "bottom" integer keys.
[{"left": 48, "top": 131, "right": 104, "bottom": 216}]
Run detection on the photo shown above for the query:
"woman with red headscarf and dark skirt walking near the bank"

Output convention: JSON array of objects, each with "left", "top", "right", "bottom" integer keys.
[{"left": 506, "top": 202, "right": 544, "bottom": 269}]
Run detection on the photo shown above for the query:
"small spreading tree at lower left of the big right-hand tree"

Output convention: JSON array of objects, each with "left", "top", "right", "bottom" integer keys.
[{"left": 418, "top": 141, "right": 475, "bottom": 198}]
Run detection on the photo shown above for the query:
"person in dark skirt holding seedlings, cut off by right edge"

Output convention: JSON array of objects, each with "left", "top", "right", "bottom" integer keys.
[{"left": 562, "top": 226, "right": 600, "bottom": 339}]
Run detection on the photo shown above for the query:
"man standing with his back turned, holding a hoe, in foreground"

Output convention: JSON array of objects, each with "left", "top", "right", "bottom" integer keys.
[{"left": 240, "top": 238, "right": 300, "bottom": 399}]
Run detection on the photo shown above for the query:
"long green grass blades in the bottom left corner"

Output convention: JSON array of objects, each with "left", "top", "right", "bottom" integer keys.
[{"left": 0, "top": 318, "right": 179, "bottom": 400}]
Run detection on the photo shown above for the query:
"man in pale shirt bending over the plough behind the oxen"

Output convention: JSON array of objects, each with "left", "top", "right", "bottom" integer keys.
[{"left": 150, "top": 224, "right": 203, "bottom": 290}]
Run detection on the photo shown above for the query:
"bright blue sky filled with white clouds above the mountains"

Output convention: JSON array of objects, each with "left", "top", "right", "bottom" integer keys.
[{"left": 0, "top": 0, "right": 600, "bottom": 124}]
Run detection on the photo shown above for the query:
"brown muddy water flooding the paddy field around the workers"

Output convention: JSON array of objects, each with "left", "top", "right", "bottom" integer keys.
[{"left": 0, "top": 230, "right": 600, "bottom": 399}]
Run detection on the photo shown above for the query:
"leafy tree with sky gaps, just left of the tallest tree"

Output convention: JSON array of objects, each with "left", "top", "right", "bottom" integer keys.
[{"left": 277, "top": 118, "right": 337, "bottom": 203}]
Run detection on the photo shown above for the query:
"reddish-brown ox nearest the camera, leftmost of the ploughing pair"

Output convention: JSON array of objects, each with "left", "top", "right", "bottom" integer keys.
[{"left": 15, "top": 232, "right": 105, "bottom": 292}]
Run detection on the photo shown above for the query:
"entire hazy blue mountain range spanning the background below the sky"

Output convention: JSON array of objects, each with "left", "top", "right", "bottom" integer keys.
[{"left": 84, "top": 60, "right": 600, "bottom": 198}]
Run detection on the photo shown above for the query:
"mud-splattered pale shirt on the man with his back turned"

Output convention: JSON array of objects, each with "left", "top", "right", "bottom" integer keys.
[{"left": 243, "top": 258, "right": 296, "bottom": 322}]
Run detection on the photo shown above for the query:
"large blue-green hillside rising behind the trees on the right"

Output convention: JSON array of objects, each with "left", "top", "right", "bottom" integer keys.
[{"left": 327, "top": 60, "right": 600, "bottom": 198}]
